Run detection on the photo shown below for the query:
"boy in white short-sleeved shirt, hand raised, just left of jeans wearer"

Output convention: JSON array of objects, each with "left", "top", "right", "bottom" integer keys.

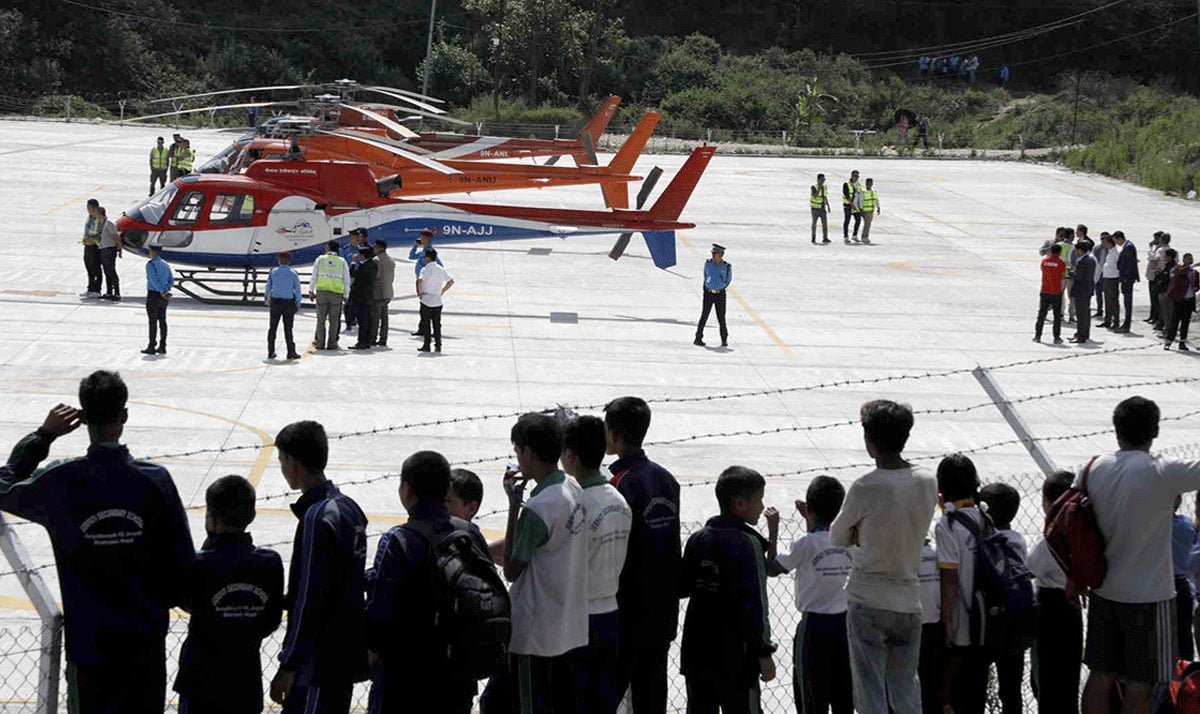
[{"left": 770, "top": 476, "right": 854, "bottom": 714}]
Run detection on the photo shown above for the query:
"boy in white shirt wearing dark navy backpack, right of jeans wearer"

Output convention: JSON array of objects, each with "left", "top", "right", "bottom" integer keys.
[{"left": 934, "top": 454, "right": 988, "bottom": 714}]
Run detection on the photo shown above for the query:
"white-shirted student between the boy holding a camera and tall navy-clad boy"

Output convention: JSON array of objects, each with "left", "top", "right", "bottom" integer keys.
[{"left": 563, "top": 416, "right": 634, "bottom": 714}]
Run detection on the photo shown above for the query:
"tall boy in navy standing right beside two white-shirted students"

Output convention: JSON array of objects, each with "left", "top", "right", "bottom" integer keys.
[{"left": 604, "top": 397, "right": 683, "bottom": 714}]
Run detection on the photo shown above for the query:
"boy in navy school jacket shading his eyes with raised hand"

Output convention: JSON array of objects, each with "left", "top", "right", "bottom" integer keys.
[{"left": 0, "top": 371, "right": 196, "bottom": 714}]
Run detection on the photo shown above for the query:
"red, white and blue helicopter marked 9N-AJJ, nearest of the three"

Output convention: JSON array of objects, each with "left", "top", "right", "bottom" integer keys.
[{"left": 116, "top": 146, "right": 716, "bottom": 302}]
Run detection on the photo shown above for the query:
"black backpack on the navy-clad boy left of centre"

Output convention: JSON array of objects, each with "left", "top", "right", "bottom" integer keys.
[{"left": 404, "top": 518, "right": 512, "bottom": 679}]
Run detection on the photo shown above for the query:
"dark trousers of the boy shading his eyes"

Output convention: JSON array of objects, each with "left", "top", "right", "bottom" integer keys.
[{"left": 67, "top": 644, "right": 167, "bottom": 714}]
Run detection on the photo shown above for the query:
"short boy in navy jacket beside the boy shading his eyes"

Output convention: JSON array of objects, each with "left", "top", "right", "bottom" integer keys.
[{"left": 175, "top": 476, "right": 283, "bottom": 714}]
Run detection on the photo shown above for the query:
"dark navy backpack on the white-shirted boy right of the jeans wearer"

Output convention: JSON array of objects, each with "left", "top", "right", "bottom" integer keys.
[{"left": 949, "top": 511, "right": 1038, "bottom": 654}]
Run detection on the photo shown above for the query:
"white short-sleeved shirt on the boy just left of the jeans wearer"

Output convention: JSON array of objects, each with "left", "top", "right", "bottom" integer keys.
[{"left": 775, "top": 529, "right": 852, "bottom": 614}]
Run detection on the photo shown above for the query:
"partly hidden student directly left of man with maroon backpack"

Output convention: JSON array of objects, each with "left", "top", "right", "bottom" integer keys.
[{"left": 1028, "top": 472, "right": 1084, "bottom": 714}]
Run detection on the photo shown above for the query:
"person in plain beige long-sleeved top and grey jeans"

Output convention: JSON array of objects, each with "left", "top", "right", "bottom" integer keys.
[{"left": 829, "top": 400, "right": 937, "bottom": 714}]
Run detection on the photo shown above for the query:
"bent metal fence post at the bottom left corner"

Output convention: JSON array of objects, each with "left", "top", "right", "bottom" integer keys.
[{"left": 0, "top": 514, "right": 62, "bottom": 714}]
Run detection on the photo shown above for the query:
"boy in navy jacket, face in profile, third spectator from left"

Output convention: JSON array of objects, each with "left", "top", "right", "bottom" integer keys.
[{"left": 271, "top": 421, "right": 367, "bottom": 714}]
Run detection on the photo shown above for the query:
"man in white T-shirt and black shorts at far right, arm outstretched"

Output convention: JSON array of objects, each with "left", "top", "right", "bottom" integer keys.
[{"left": 1076, "top": 397, "right": 1200, "bottom": 714}]
